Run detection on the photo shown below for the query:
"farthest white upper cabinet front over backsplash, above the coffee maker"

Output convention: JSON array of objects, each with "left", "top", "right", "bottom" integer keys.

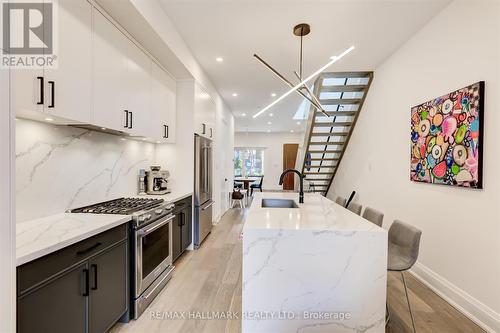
[{"left": 151, "top": 62, "right": 177, "bottom": 143}]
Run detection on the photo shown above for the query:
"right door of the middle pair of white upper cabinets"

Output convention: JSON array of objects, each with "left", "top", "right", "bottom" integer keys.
[{"left": 126, "top": 40, "right": 150, "bottom": 137}]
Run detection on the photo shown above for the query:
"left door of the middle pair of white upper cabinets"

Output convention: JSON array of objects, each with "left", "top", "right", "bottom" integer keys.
[{"left": 92, "top": 8, "right": 131, "bottom": 132}]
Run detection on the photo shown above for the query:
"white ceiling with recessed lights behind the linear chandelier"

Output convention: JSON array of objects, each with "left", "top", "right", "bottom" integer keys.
[{"left": 160, "top": 0, "right": 450, "bottom": 132}]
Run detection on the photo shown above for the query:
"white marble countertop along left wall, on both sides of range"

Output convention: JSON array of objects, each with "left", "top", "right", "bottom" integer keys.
[{"left": 16, "top": 191, "right": 192, "bottom": 266}]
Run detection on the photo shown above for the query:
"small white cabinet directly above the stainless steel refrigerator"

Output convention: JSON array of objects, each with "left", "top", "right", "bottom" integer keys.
[{"left": 194, "top": 83, "right": 216, "bottom": 139}]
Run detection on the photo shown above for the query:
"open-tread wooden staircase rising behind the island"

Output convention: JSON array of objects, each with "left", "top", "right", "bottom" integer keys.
[{"left": 302, "top": 72, "right": 373, "bottom": 195}]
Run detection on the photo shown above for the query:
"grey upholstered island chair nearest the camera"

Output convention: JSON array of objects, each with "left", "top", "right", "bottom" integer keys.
[{"left": 387, "top": 220, "right": 422, "bottom": 333}]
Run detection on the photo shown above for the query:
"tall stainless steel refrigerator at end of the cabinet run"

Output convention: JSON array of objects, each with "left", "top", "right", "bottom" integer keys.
[{"left": 194, "top": 134, "right": 214, "bottom": 249}]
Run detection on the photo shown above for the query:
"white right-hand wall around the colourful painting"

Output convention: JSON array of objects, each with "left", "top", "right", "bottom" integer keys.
[{"left": 328, "top": 0, "right": 500, "bottom": 332}]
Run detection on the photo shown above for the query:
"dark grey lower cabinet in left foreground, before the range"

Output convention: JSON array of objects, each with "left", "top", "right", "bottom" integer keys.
[{"left": 17, "top": 225, "right": 129, "bottom": 333}]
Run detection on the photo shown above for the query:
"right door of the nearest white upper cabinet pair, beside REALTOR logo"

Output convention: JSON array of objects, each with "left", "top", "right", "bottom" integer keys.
[{"left": 44, "top": 0, "right": 92, "bottom": 123}]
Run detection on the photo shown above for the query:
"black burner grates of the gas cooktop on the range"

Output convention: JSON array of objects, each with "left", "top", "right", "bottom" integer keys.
[{"left": 70, "top": 198, "right": 164, "bottom": 215}]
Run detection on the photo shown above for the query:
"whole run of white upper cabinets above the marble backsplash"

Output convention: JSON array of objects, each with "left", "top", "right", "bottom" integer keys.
[{"left": 12, "top": 0, "right": 180, "bottom": 143}]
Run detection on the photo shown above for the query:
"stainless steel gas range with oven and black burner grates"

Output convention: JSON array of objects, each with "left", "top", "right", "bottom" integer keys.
[{"left": 70, "top": 198, "right": 175, "bottom": 319}]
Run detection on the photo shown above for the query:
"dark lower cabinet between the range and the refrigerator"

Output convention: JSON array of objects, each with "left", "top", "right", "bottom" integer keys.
[{"left": 172, "top": 197, "right": 193, "bottom": 261}]
